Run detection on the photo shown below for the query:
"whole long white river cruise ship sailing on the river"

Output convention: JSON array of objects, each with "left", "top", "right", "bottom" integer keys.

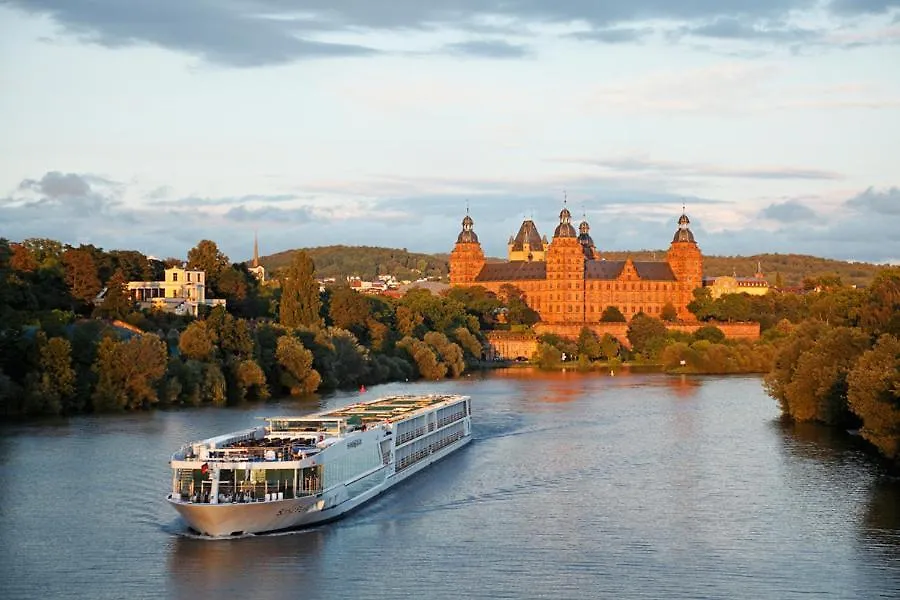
[{"left": 167, "top": 395, "right": 472, "bottom": 537}]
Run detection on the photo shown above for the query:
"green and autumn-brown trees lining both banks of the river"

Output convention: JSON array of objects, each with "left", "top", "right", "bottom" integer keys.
[{"left": 0, "top": 240, "right": 900, "bottom": 460}]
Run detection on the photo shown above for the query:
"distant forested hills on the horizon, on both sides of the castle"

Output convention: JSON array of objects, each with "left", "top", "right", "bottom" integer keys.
[{"left": 260, "top": 246, "right": 883, "bottom": 286}]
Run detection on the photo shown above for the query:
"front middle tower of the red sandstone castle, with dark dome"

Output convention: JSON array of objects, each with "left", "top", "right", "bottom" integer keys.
[{"left": 542, "top": 200, "right": 585, "bottom": 323}]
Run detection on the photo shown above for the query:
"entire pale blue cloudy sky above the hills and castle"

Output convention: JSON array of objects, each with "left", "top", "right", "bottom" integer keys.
[{"left": 0, "top": 0, "right": 900, "bottom": 263}]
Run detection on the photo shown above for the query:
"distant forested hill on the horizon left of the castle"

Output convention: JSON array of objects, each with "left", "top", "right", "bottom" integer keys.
[{"left": 259, "top": 246, "right": 450, "bottom": 281}]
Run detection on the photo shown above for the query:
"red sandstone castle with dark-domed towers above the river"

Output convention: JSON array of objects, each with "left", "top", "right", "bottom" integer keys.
[{"left": 450, "top": 208, "right": 703, "bottom": 325}]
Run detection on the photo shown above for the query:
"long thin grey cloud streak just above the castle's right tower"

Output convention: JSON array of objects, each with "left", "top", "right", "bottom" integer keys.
[{"left": 558, "top": 157, "right": 841, "bottom": 180}]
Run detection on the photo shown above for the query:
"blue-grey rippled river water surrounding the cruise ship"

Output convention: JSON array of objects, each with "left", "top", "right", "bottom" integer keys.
[{"left": 0, "top": 369, "right": 900, "bottom": 600}]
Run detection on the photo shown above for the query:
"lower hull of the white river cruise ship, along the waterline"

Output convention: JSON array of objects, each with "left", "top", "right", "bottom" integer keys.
[{"left": 167, "top": 434, "right": 472, "bottom": 538}]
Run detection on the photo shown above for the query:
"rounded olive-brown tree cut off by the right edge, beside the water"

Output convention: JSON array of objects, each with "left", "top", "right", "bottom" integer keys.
[{"left": 847, "top": 334, "right": 900, "bottom": 461}]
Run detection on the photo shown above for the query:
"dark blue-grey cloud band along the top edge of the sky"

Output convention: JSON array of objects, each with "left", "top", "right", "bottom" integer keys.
[{"left": 12, "top": 0, "right": 897, "bottom": 67}]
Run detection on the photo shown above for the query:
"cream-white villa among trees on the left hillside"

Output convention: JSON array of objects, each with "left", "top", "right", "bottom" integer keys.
[{"left": 128, "top": 267, "right": 225, "bottom": 316}]
